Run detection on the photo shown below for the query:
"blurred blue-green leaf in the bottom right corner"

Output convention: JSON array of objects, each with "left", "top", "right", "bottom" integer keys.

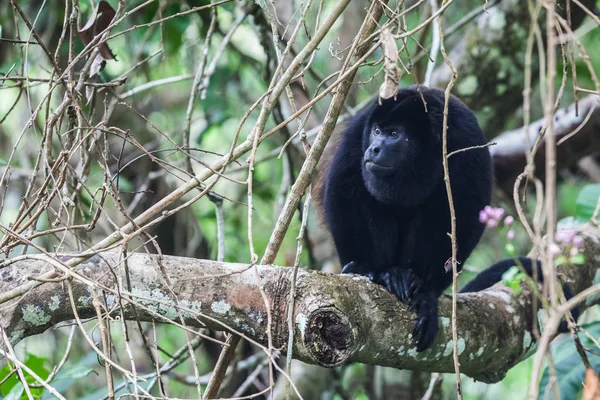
[{"left": 538, "top": 322, "right": 600, "bottom": 400}]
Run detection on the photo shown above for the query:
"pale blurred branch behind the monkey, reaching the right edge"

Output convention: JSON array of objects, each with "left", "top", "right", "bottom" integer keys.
[{"left": 490, "top": 95, "right": 600, "bottom": 192}]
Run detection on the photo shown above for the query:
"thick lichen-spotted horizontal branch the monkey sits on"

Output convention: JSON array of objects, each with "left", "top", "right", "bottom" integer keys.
[{"left": 0, "top": 223, "right": 600, "bottom": 382}]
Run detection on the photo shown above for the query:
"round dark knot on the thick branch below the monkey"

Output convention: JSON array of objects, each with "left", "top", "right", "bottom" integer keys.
[{"left": 304, "top": 307, "right": 356, "bottom": 367}]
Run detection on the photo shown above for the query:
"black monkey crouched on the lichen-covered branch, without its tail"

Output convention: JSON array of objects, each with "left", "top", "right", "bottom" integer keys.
[{"left": 323, "top": 86, "right": 497, "bottom": 351}]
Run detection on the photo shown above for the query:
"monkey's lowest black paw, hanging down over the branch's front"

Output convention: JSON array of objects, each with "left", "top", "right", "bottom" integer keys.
[{"left": 410, "top": 292, "right": 438, "bottom": 352}]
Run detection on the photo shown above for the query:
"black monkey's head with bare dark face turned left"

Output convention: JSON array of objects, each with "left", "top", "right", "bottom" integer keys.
[{"left": 362, "top": 90, "right": 443, "bottom": 206}]
